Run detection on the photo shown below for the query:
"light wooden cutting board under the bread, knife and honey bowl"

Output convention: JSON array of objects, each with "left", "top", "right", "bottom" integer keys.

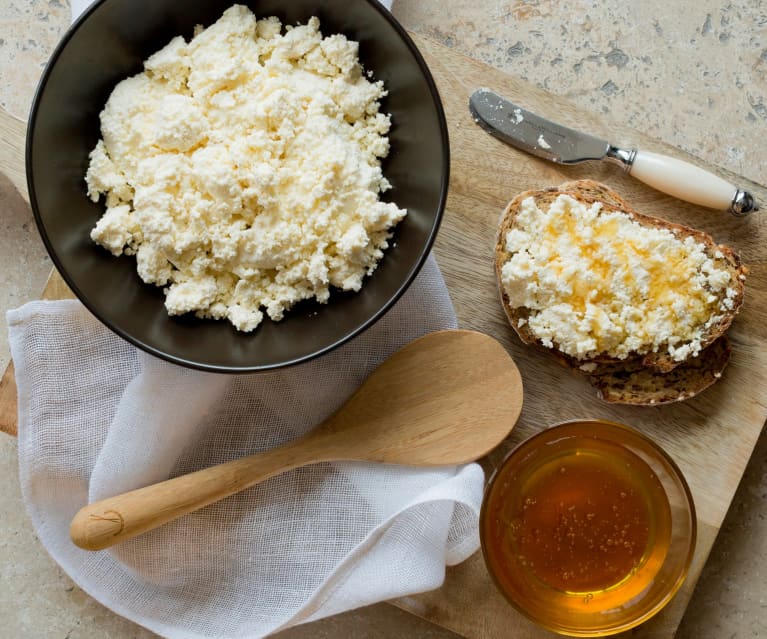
[{"left": 0, "top": 36, "right": 767, "bottom": 639}]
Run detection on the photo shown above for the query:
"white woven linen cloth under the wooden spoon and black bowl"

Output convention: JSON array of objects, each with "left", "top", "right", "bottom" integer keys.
[{"left": 7, "top": 1, "right": 484, "bottom": 639}]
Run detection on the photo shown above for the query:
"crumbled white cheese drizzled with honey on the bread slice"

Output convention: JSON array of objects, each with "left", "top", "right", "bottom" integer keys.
[{"left": 501, "top": 194, "right": 737, "bottom": 362}]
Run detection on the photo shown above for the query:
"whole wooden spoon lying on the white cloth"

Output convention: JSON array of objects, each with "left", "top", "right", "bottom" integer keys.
[{"left": 70, "top": 330, "right": 522, "bottom": 550}]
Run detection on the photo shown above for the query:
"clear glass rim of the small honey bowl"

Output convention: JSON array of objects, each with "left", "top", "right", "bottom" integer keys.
[{"left": 479, "top": 418, "right": 698, "bottom": 637}]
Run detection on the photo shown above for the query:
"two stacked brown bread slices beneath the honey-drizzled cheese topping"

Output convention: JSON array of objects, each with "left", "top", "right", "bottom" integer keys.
[{"left": 495, "top": 180, "right": 747, "bottom": 405}]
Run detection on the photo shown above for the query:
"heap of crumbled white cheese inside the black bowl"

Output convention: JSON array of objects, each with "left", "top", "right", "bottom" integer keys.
[{"left": 86, "top": 5, "right": 406, "bottom": 331}]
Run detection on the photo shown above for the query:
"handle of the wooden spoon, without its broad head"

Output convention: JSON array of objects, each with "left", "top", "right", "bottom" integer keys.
[{"left": 69, "top": 442, "right": 310, "bottom": 550}]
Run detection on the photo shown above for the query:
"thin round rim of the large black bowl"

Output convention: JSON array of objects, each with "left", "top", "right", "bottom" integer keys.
[{"left": 24, "top": 0, "right": 450, "bottom": 374}]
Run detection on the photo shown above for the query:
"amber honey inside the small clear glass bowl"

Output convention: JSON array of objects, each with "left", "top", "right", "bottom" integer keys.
[{"left": 481, "top": 420, "right": 672, "bottom": 624}]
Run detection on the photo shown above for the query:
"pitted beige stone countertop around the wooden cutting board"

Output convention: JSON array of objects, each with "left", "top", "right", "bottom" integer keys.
[{"left": 0, "top": 0, "right": 767, "bottom": 639}]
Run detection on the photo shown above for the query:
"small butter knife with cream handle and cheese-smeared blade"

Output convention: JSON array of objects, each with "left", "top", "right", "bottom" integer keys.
[{"left": 469, "top": 89, "right": 759, "bottom": 216}]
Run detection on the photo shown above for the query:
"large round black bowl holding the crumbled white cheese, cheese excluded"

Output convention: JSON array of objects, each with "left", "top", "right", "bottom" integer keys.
[{"left": 27, "top": 0, "right": 449, "bottom": 372}]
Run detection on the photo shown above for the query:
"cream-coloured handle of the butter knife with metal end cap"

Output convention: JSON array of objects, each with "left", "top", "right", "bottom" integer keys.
[{"left": 627, "top": 151, "right": 757, "bottom": 215}]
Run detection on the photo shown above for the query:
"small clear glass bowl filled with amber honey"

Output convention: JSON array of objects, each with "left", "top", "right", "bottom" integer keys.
[{"left": 480, "top": 420, "right": 697, "bottom": 637}]
